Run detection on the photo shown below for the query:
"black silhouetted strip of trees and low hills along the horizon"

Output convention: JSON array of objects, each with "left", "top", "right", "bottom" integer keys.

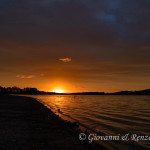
[{"left": 0, "top": 86, "right": 150, "bottom": 95}]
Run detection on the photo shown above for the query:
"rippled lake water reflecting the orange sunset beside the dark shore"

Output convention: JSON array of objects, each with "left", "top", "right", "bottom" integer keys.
[{"left": 28, "top": 95, "right": 150, "bottom": 150}]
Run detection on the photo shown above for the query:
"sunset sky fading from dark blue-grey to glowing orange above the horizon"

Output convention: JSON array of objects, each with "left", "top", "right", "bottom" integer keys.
[{"left": 0, "top": 0, "right": 150, "bottom": 92}]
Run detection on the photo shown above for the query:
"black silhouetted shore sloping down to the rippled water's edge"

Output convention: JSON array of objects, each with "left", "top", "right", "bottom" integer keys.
[{"left": 0, "top": 95, "right": 103, "bottom": 150}]
